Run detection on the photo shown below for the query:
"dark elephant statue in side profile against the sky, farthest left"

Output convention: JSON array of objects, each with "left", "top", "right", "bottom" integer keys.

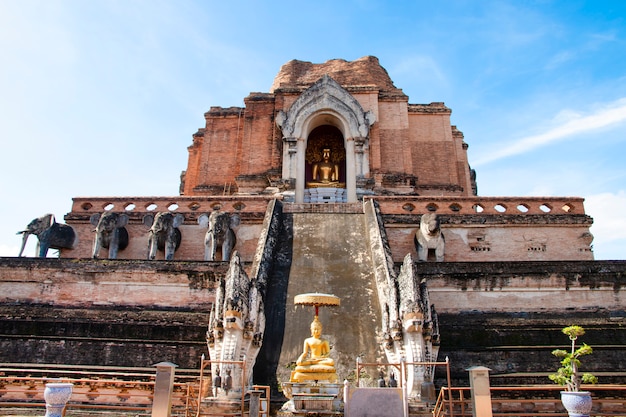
[{"left": 17, "top": 213, "right": 76, "bottom": 258}]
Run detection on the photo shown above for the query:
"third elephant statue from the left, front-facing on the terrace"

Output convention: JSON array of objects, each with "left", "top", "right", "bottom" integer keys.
[{"left": 143, "top": 212, "right": 185, "bottom": 261}]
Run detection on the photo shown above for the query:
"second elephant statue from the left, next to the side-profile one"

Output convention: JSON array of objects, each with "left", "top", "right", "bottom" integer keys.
[{"left": 89, "top": 211, "right": 128, "bottom": 259}]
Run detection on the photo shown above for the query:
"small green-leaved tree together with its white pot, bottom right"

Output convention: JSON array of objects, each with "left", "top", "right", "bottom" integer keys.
[{"left": 548, "top": 326, "right": 598, "bottom": 417}]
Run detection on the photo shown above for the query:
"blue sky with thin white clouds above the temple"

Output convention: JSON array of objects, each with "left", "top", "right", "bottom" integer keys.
[{"left": 0, "top": 0, "right": 626, "bottom": 259}]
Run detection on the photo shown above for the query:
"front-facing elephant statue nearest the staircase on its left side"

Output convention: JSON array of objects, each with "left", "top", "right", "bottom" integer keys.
[{"left": 198, "top": 210, "right": 239, "bottom": 261}]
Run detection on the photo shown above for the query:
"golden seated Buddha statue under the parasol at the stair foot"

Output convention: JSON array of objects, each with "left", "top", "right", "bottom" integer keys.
[{"left": 291, "top": 316, "right": 337, "bottom": 382}]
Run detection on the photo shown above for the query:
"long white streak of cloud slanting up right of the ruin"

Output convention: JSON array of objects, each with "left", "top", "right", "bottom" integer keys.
[{"left": 473, "top": 98, "right": 626, "bottom": 166}]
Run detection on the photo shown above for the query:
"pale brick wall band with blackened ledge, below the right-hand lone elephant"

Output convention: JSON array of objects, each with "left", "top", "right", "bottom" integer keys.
[{"left": 417, "top": 261, "right": 626, "bottom": 312}]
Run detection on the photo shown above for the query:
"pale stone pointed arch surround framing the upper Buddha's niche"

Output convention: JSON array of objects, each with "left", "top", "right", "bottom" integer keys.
[{"left": 276, "top": 75, "right": 375, "bottom": 203}]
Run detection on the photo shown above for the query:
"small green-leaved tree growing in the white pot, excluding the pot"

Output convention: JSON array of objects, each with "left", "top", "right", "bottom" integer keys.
[{"left": 548, "top": 326, "right": 598, "bottom": 392}]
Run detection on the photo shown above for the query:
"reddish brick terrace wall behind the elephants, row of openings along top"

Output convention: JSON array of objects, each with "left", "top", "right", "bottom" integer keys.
[{"left": 61, "top": 194, "right": 593, "bottom": 262}]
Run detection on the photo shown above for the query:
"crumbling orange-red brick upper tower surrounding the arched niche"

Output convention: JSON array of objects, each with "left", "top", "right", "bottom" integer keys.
[{"left": 183, "top": 57, "right": 472, "bottom": 196}]
